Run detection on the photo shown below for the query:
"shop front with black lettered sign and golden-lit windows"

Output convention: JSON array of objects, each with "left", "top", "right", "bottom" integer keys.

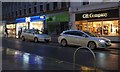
[{"left": 75, "top": 9, "right": 120, "bottom": 41}]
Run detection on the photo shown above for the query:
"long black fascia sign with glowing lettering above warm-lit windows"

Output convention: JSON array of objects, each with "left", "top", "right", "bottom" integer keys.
[{"left": 75, "top": 9, "right": 119, "bottom": 21}]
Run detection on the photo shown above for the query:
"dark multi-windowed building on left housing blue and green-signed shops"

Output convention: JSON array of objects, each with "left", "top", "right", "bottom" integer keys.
[{"left": 2, "top": 2, "right": 69, "bottom": 36}]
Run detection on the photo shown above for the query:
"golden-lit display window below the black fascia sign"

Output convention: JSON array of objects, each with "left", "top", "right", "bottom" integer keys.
[{"left": 76, "top": 20, "right": 119, "bottom": 36}]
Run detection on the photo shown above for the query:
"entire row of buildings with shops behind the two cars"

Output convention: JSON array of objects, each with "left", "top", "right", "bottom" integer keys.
[{"left": 2, "top": 0, "right": 120, "bottom": 41}]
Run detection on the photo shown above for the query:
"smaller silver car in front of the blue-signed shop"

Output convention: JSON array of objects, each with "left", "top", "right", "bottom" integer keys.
[{"left": 21, "top": 29, "right": 51, "bottom": 43}]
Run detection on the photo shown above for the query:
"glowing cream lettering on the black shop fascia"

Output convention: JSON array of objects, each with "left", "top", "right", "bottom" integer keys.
[{"left": 82, "top": 13, "right": 107, "bottom": 18}]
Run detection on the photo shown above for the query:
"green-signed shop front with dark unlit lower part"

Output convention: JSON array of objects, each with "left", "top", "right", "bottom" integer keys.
[{"left": 46, "top": 12, "right": 69, "bottom": 34}]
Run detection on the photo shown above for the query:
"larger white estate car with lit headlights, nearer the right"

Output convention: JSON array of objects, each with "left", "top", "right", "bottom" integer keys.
[{"left": 58, "top": 30, "right": 111, "bottom": 49}]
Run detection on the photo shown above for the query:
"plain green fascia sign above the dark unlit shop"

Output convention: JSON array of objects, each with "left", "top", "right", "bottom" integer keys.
[{"left": 46, "top": 12, "right": 69, "bottom": 22}]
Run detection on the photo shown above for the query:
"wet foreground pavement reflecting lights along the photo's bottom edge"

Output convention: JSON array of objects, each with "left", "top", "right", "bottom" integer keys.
[{"left": 2, "top": 48, "right": 103, "bottom": 72}]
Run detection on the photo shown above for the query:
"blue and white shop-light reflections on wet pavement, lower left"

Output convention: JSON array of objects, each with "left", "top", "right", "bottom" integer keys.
[{"left": 2, "top": 48, "right": 44, "bottom": 70}]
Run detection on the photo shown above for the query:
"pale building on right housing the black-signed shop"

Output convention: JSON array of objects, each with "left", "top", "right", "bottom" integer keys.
[{"left": 69, "top": 1, "right": 120, "bottom": 41}]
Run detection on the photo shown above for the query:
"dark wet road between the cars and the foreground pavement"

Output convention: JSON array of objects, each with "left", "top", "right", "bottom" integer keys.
[{"left": 2, "top": 38, "right": 120, "bottom": 70}]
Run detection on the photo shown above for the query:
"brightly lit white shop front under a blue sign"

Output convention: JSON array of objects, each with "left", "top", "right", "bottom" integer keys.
[{"left": 16, "top": 15, "right": 46, "bottom": 38}]
